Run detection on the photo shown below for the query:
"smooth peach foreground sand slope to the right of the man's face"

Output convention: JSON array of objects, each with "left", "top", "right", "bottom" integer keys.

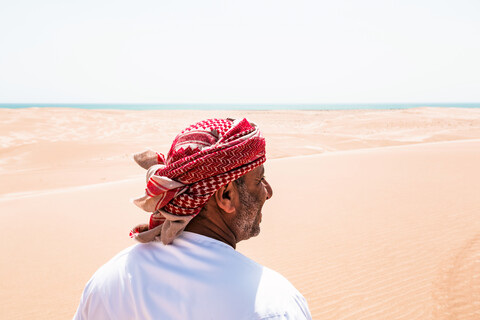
[{"left": 239, "top": 140, "right": 480, "bottom": 319}]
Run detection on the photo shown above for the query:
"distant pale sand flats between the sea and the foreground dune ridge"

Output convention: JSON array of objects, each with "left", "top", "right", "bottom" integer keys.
[{"left": 0, "top": 108, "right": 480, "bottom": 195}]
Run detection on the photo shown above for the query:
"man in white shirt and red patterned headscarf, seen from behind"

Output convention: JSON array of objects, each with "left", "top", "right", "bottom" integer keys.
[{"left": 74, "top": 119, "right": 311, "bottom": 320}]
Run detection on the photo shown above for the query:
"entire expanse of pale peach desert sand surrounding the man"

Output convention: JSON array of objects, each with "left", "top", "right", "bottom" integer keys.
[{"left": 0, "top": 108, "right": 480, "bottom": 319}]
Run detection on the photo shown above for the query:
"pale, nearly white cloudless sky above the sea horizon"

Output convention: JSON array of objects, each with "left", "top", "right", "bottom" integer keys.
[{"left": 0, "top": 0, "right": 480, "bottom": 104}]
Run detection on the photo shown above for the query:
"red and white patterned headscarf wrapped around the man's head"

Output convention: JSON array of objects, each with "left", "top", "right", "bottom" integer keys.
[{"left": 131, "top": 119, "right": 265, "bottom": 244}]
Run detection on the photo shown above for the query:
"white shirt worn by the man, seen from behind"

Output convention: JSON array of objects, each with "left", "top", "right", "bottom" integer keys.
[{"left": 74, "top": 232, "right": 311, "bottom": 320}]
